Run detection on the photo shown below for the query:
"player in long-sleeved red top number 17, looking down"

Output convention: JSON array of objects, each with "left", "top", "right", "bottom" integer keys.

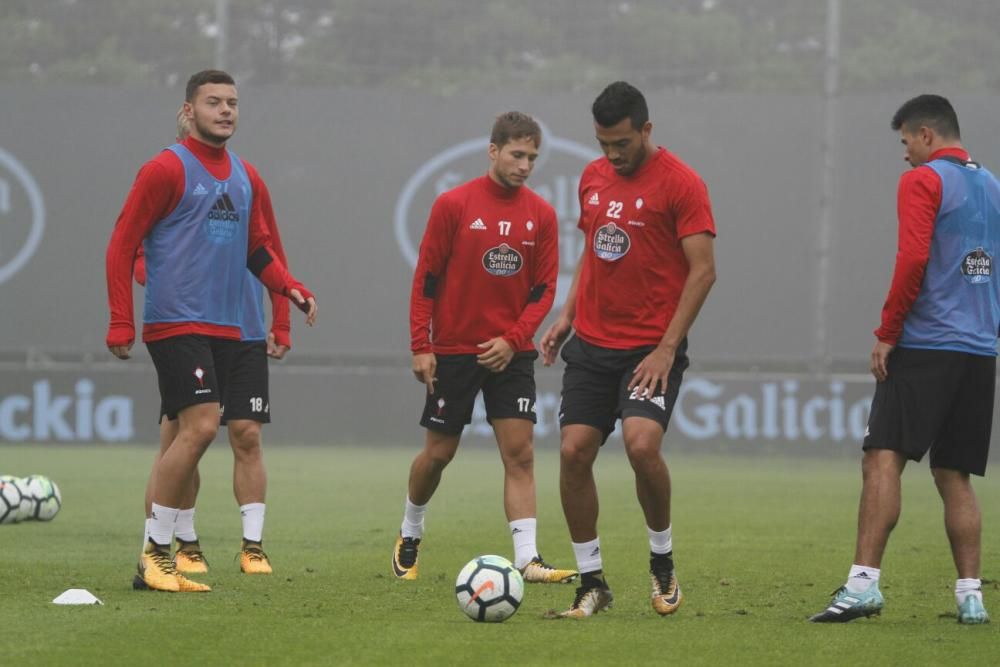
[{"left": 392, "top": 111, "right": 576, "bottom": 583}]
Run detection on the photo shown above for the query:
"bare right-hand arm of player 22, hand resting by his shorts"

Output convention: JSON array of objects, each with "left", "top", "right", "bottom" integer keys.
[{"left": 628, "top": 233, "right": 715, "bottom": 396}]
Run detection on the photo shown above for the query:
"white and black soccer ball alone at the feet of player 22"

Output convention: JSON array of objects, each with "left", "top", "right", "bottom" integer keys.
[{"left": 455, "top": 556, "right": 524, "bottom": 623}]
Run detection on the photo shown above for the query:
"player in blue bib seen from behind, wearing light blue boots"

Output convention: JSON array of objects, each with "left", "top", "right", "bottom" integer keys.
[{"left": 809, "top": 95, "right": 1000, "bottom": 625}]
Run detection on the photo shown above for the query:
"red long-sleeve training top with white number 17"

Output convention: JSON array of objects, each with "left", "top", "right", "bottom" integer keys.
[{"left": 410, "top": 176, "right": 559, "bottom": 354}]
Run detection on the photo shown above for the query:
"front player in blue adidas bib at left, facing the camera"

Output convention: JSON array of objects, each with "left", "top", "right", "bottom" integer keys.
[{"left": 106, "top": 70, "right": 316, "bottom": 592}]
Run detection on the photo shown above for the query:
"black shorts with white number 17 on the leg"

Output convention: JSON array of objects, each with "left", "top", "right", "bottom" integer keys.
[{"left": 420, "top": 350, "right": 538, "bottom": 435}]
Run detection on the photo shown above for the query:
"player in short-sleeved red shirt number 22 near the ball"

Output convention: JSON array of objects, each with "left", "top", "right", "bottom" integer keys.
[{"left": 541, "top": 81, "right": 715, "bottom": 618}]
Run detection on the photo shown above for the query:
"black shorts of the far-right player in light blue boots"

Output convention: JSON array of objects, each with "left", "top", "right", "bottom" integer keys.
[{"left": 863, "top": 347, "right": 996, "bottom": 476}]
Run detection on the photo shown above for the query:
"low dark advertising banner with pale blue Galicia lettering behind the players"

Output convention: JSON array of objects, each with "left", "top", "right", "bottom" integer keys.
[{"left": 0, "top": 361, "right": 892, "bottom": 452}]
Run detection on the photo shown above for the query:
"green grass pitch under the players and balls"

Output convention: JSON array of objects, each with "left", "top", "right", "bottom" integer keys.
[{"left": 0, "top": 439, "right": 1000, "bottom": 666}]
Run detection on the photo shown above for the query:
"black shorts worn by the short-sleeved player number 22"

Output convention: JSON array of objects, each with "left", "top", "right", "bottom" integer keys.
[{"left": 559, "top": 336, "right": 688, "bottom": 440}]
